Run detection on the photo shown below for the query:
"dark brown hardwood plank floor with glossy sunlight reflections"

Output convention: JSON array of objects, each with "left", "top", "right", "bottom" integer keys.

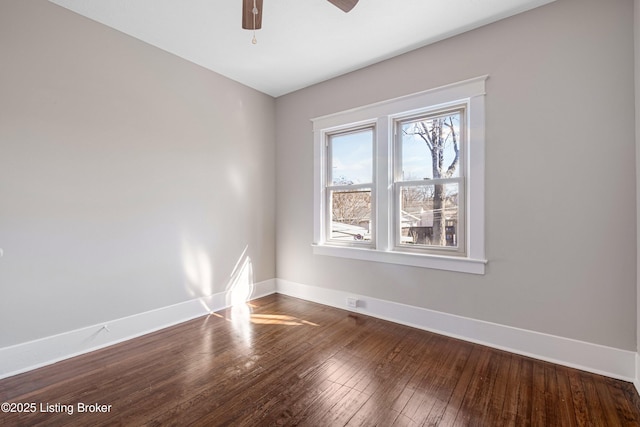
[{"left": 0, "top": 295, "right": 640, "bottom": 426}]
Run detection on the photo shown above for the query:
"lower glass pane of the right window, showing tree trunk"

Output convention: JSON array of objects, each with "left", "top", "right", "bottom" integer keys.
[{"left": 400, "top": 183, "right": 460, "bottom": 247}]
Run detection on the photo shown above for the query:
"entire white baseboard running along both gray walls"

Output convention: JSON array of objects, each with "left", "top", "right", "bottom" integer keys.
[{"left": 0, "top": 279, "right": 640, "bottom": 384}]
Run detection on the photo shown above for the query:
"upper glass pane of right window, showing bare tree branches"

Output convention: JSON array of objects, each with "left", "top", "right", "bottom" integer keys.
[{"left": 400, "top": 111, "right": 461, "bottom": 181}]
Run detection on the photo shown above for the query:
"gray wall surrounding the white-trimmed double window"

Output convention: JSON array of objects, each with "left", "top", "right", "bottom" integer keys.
[{"left": 276, "top": 0, "right": 636, "bottom": 350}]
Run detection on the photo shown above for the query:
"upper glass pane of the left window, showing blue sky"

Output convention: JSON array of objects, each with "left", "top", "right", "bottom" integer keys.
[{"left": 329, "top": 128, "right": 373, "bottom": 185}]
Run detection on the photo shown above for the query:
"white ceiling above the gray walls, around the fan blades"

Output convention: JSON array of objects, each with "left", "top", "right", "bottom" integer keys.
[{"left": 50, "top": 0, "right": 554, "bottom": 96}]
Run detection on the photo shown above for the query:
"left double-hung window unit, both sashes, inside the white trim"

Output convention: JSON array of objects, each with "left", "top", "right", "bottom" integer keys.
[{"left": 325, "top": 126, "right": 375, "bottom": 246}]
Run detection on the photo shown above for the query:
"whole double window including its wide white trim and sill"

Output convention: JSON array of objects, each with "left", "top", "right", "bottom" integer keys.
[{"left": 313, "top": 76, "right": 486, "bottom": 274}]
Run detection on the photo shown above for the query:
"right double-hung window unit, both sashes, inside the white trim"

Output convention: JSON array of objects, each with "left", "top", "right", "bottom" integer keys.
[{"left": 394, "top": 108, "right": 467, "bottom": 255}]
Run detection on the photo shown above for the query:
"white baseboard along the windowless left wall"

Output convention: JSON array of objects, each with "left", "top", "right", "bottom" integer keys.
[{"left": 0, "top": 279, "right": 276, "bottom": 379}]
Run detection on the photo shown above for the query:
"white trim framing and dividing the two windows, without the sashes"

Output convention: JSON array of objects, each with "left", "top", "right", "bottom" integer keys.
[{"left": 312, "top": 76, "right": 488, "bottom": 274}]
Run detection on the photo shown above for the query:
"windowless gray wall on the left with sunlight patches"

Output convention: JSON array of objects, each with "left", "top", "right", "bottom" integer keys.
[{"left": 0, "top": 0, "right": 275, "bottom": 347}]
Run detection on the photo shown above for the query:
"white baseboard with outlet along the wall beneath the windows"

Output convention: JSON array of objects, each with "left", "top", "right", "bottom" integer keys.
[{"left": 276, "top": 279, "right": 640, "bottom": 382}]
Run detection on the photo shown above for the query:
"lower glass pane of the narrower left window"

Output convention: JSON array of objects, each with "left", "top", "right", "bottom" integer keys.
[{"left": 330, "top": 188, "right": 371, "bottom": 242}]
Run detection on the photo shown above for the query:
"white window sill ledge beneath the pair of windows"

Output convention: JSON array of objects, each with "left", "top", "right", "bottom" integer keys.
[{"left": 312, "top": 244, "right": 487, "bottom": 274}]
